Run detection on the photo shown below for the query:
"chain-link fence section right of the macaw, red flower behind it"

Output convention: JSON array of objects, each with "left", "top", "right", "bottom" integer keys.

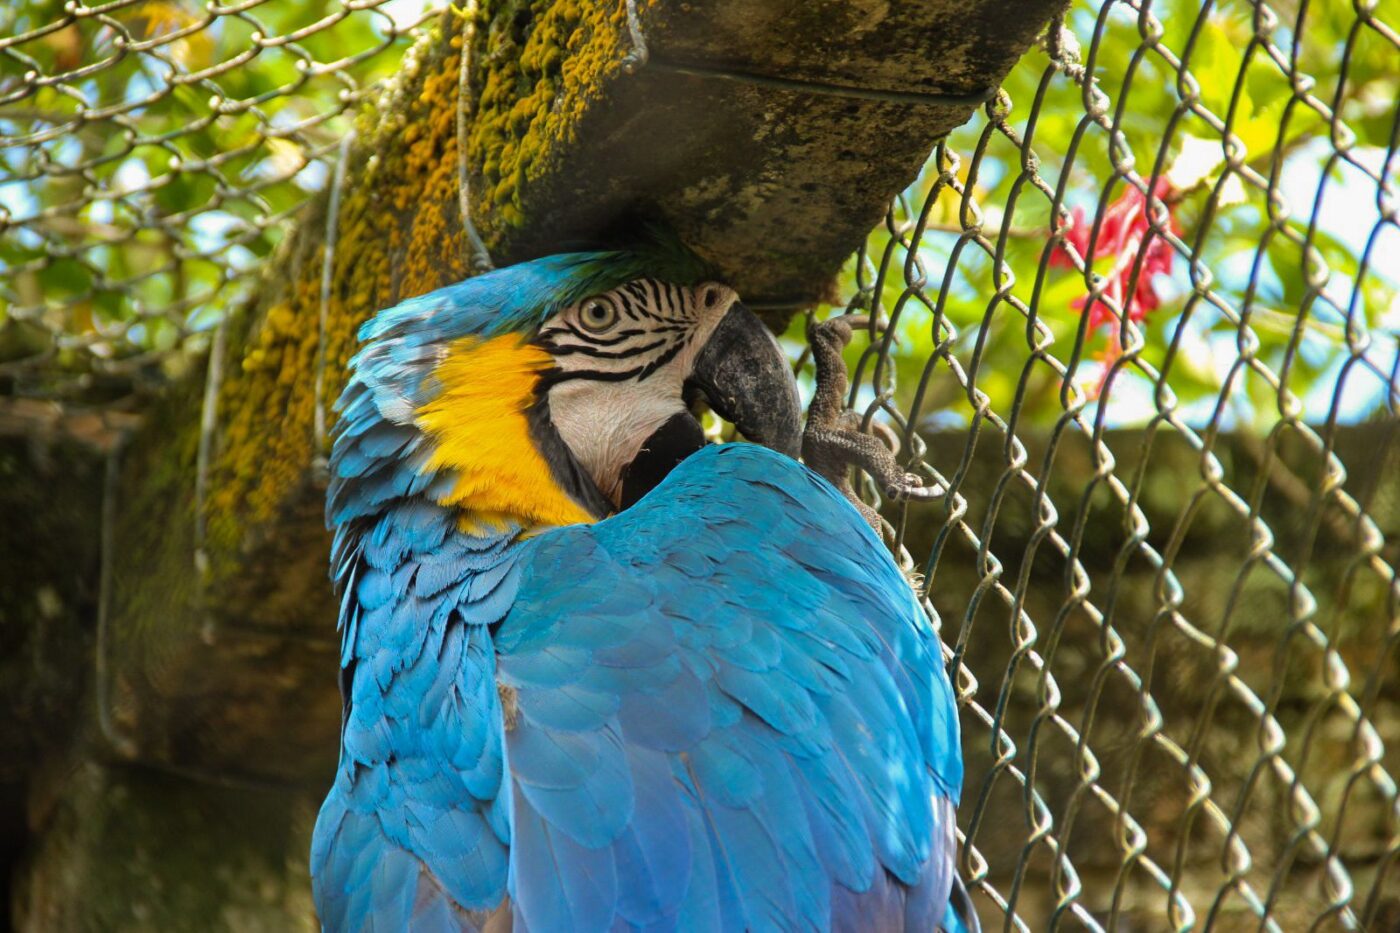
[{"left": 812, "top": 3, "right": 1400, "bottom": 930}]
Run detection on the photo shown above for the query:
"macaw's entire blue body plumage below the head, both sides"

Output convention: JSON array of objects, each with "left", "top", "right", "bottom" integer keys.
[{"left": 312, "top": 439, "right": 962, "bottom": 933}]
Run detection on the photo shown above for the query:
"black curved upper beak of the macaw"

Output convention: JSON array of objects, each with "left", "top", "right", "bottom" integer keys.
[{"left": 686, "top": 301, "right": 802, "bottom": 458}]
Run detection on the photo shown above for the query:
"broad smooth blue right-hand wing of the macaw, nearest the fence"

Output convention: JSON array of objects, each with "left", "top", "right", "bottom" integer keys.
[{"left": 496, "top": 445, "right": 960, "bottom": 930}]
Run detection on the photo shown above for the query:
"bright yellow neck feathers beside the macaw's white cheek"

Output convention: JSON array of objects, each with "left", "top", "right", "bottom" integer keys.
[{"left": 419, "top": 333, "right": 594, "bottom": 528}]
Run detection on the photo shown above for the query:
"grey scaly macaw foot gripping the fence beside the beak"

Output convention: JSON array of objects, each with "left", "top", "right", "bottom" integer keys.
[{"left": 802, "top": 315, "right": 941, "bottom": 539}]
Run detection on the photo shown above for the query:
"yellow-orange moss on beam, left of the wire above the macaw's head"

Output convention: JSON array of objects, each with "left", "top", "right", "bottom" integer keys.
[{"left": 206, "top": 39, "right": 468, "bottom": 555}]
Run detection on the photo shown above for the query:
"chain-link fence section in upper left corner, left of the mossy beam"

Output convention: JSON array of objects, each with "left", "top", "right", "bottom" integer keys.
[{"left": 0, "top": 0, "right": 433, "bottom": 401}]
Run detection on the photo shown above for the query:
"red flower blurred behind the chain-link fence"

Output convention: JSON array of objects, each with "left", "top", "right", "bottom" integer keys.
[{"left": 1050, "top": 178, "right": 1182, "bottom": 328}]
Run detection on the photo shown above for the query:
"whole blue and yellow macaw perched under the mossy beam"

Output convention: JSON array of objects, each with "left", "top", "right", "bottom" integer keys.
[{"left": 312, "top": 240, "right": 976, "bottom": 933}]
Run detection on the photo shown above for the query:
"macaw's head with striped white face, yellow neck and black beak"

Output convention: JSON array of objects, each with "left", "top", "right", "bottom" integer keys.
[{"left": 330, "top": 239, "right": 801, "bottom": 528}]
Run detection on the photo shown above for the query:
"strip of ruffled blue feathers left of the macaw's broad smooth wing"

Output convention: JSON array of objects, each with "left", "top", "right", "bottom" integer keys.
[{"left": 312, "top": 482, "right": 512, "bottom": 930}]
